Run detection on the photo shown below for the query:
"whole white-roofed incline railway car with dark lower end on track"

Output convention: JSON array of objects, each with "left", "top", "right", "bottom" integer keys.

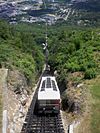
[{"left": 37, "top": 76, "right": 60, "bottom": 113}]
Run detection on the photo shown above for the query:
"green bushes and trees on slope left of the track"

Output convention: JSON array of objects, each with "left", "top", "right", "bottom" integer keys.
[{"left": 0, "top": 21, "right": 44, "bottom": 84}]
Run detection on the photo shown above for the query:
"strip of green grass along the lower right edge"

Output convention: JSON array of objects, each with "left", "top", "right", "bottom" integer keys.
[{"left": 90, "top": 77, "right": 100, "bottom": 133}]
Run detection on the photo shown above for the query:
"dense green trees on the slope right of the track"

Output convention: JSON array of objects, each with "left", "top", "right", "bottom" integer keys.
[{"left": 49, "top": 27, "right": 100, "bottom": 79}]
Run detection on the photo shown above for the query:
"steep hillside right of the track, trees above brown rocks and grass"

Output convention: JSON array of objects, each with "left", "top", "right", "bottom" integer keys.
[{"left": 49, "top": 25, "right": 100, "bottom": 133}]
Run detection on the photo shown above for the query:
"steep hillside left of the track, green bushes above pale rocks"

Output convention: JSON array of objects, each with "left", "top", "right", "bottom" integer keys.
[{"left": 0, "top": 20, "right": 45, "bottom": 133}]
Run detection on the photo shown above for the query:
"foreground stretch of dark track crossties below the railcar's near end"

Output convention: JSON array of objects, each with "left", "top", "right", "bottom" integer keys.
[{"left": 21, "top": 114, "right": 64, "bottom": 133}]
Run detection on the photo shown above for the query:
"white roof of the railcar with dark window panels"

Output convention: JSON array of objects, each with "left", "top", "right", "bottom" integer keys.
[{"left": 38, "top": 76, "right": 60, "bottom": 100}]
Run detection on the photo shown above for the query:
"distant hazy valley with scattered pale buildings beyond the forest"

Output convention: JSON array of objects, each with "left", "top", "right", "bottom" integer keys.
[{"left": 0, "top": 0, "right": 100, "bottom": 26}]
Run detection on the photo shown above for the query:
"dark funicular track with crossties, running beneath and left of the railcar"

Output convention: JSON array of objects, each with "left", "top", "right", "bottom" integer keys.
[{"left": 21, "top": 71, "right": 64, "bottom": 133}]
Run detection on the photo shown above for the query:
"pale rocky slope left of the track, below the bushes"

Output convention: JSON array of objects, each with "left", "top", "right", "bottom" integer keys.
[{"left": 8, "top": 70, "right": 33, "bottom": 133}]
